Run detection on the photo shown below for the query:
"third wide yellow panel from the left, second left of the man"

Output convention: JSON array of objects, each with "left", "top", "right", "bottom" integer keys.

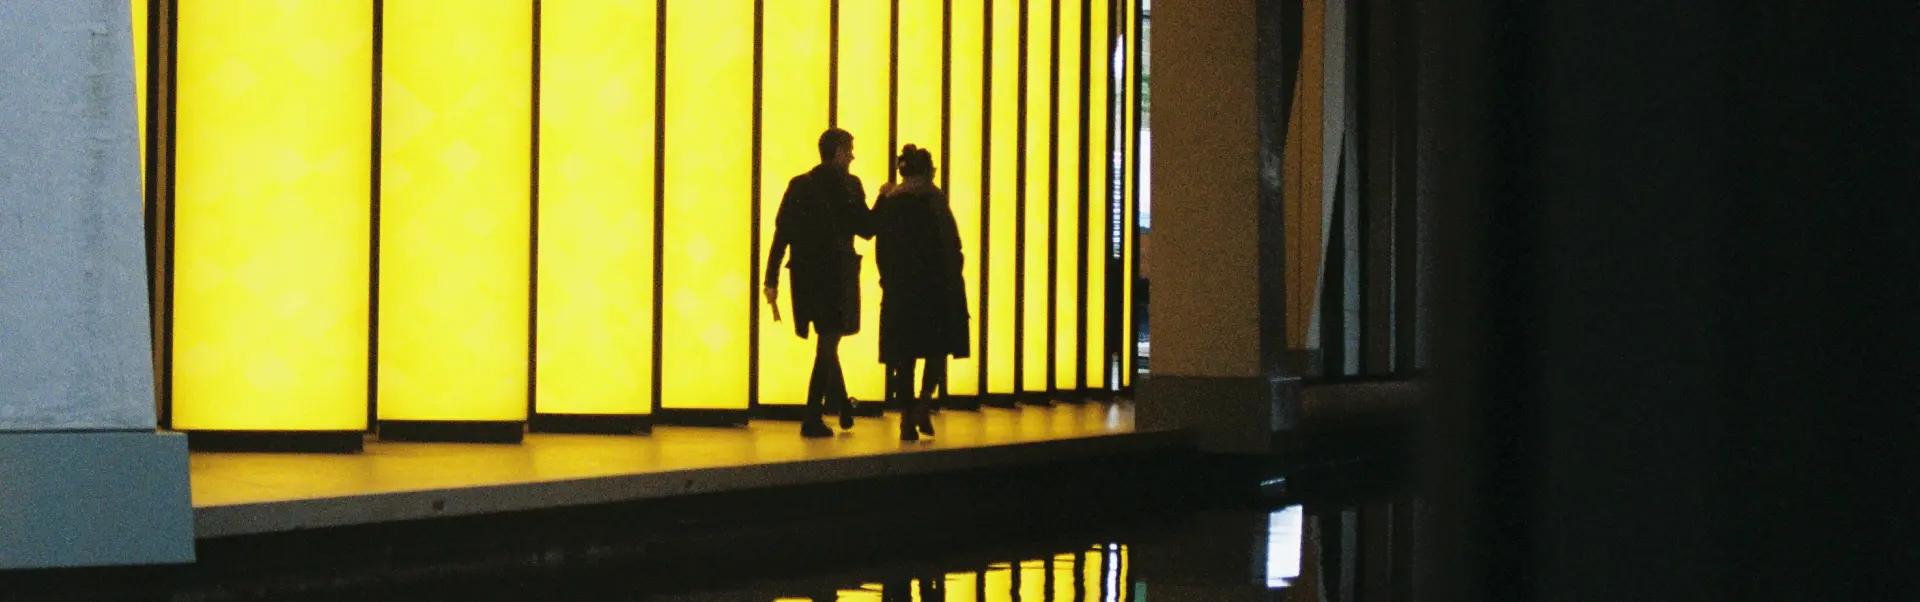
[{"left": 534, "top": 0, "right": 655, "bottom": 414}]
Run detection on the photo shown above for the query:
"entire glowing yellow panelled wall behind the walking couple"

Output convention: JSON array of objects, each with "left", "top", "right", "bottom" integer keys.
[{"left": 161, "top": 0, "right": 1139, "bottom": 429}]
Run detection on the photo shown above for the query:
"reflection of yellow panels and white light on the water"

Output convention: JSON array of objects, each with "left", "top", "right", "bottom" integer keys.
[{"left": 725, "top": 498, "right": 1413, "bottom": 602}]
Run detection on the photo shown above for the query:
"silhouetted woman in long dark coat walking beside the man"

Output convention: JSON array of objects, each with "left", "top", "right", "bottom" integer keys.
[{"left": 874, "top": 144, "right": 972, "bottom": 441}]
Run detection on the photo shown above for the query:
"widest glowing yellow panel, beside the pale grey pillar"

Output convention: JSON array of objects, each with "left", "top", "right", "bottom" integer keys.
[{"left": 170, "top": 0, "right": 372, "bottom": 431}]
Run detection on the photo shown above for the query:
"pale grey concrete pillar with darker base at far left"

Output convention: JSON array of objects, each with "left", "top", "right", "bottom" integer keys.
[{"left": 0, "top": 0, "right": 192, "bottom": 569}]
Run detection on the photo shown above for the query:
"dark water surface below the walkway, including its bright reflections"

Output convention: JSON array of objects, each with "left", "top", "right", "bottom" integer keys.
[{"left": 0, "top": 456, "right": 1419, "bottom": 602}]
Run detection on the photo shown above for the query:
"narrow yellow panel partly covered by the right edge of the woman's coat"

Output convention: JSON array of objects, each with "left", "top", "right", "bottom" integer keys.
[{"left": 940, "top": 0, "right": 987, "bottom": 395}]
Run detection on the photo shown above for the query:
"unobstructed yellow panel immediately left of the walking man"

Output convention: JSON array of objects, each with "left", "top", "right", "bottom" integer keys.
[{"left": 660, "top": 0, "right": 758, "bottom": 410}]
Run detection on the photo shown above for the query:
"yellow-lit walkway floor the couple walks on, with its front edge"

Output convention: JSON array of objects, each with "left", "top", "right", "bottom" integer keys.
[{"left": 190, "top": 401, "right": 1188, "bottom": 537}]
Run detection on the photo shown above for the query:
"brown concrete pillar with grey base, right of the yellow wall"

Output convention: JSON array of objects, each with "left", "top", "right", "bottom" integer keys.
[{"left": 1137, "top": 0, "right": 1288, "bottom": 452}]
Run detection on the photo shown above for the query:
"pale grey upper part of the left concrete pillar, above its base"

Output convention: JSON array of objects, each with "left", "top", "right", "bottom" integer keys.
[{"left": 0, "top": 0, "right": 154, "bottom": 431}]
